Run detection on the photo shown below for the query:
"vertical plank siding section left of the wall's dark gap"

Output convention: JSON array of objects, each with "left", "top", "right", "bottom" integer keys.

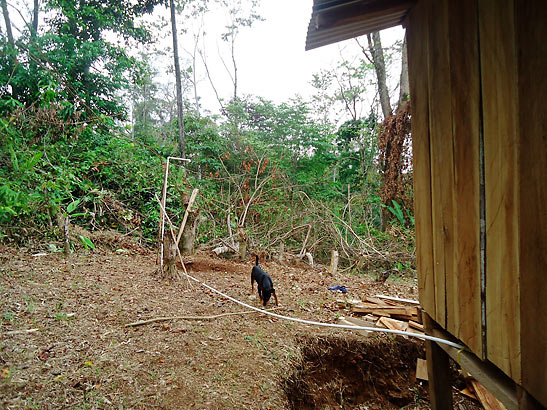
[{"left": 408, "top": 0, "right": 482, "bottom": 356}]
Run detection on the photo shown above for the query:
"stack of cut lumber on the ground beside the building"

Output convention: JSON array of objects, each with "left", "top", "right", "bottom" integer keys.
[{"left": 338, "top": 297, "right": 424, "bottom": 334}]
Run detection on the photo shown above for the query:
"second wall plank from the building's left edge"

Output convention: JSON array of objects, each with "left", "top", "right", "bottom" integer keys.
[{"left": 428, "top": 0, "right": 456, "bottom": 333}]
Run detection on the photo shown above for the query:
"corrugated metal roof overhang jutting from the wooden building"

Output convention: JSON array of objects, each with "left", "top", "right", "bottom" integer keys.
[{"left": 306, "top": 0, "right": 414, "bottom": 50}]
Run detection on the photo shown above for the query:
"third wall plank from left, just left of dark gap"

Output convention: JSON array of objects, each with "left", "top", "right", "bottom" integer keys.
[{"left": 447, "top": 0, "right": 483, "bottom": 357}]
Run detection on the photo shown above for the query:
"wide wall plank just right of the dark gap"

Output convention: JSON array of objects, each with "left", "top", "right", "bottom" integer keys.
[{"left": 479, "top": 0, "right": 521, "bottom": 383}]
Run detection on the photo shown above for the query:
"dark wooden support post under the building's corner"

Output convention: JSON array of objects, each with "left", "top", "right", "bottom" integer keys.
[{"left": 422, "top": 312, "right": 453, "bottom": 410}]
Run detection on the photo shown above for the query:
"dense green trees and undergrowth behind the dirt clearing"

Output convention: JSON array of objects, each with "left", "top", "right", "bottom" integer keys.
[{"left": 0, "top": 0, "right": 413, "bottom": 270}]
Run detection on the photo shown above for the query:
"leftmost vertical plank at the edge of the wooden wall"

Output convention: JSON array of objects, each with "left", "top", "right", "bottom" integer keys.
[{"left": 407, "top": 1, "right": 436, "bottom": 317}]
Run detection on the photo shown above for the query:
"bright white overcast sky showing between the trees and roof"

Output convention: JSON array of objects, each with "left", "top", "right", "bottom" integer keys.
[{"left": 1, "top": 0, "right": 404, "bottom": 118}]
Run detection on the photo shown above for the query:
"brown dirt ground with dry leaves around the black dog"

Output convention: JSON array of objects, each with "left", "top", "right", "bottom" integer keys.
[{"left": 0, "top": 239, "right": 477, "bottom": 409}]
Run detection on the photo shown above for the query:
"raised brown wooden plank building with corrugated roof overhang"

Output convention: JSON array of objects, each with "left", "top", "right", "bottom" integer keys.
[{"left": 306, "top": 0, "right": 547, "bottom": 408}]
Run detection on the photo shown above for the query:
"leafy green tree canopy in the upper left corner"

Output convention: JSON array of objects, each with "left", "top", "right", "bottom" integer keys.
[{"left": 0, "top": 0, "right": 167, "bottom": 118}]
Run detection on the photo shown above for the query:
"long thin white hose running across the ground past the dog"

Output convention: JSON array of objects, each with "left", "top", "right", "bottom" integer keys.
[{"left": 178, "top": 273, "right": 465, "bottom": 350}]
